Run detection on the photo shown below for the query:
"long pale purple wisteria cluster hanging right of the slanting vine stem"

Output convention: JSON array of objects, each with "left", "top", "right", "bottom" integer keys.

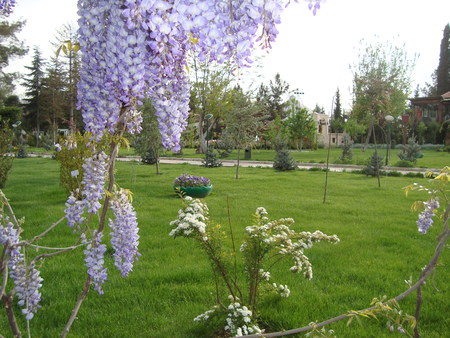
[{"left": 109, "top": 189, "right": 140, "bottom": 277}]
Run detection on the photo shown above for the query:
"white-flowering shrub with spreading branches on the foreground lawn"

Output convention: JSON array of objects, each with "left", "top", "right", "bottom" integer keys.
[{"left": 169, "top": 197, "right": 339, "bottom": 336}]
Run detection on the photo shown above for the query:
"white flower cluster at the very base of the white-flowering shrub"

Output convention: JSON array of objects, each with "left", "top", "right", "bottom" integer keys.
[{"left": 225, "top": 296, "right": 263, "bottom": 336}]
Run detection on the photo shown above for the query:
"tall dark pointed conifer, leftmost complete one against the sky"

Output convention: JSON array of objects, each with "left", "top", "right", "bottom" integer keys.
[{"left": 23, "top": 46, "right": 44, "bottom": 146}]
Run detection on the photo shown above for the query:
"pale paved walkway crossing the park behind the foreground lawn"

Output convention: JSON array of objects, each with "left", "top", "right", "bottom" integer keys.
[{"left": 28, "top": 153, "right": 440, "bottom": 174}]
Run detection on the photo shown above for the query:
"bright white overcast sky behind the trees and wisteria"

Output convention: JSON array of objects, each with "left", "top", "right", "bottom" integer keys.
[{"left": 4, "top": 0, "right": 450, "bottom": 112}]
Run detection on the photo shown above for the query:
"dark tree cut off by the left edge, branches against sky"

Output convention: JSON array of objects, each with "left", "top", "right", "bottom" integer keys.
[{"left": 0, "top": 16, "right": 28, "bottom": 105}]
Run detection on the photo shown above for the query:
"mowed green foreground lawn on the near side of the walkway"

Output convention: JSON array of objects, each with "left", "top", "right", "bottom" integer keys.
[{"left": 0, "top": 158, "right": 450, "bottom": 338}]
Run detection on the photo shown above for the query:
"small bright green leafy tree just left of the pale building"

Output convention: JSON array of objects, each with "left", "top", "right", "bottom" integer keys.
[{"left": 286, "top": 101, "right": 317, "bottom": 151}]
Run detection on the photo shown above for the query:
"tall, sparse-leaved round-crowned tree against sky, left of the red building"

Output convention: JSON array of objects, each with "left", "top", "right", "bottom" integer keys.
[{"left": 351, "top": 39, "right": 414, "bottom": 150}]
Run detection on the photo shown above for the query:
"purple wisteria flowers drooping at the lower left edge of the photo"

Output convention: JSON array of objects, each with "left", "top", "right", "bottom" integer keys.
[{"left": 0, "top": 214, "right": 43, "bottom": 320}]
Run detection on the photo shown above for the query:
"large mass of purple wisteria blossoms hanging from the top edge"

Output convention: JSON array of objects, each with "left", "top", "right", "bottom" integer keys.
[{"left": 78, "top": 0, "right": 320, "bottom": 151}]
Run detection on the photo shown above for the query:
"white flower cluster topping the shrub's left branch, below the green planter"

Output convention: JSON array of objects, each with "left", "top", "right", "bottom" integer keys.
[{"left": 169, "top": 196, "right": 208, "bottom": 241}]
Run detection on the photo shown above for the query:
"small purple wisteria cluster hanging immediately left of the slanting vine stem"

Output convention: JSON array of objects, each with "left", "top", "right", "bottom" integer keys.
[{"left": 81, "top": 232, "right": 108, "bottom": 295}]
